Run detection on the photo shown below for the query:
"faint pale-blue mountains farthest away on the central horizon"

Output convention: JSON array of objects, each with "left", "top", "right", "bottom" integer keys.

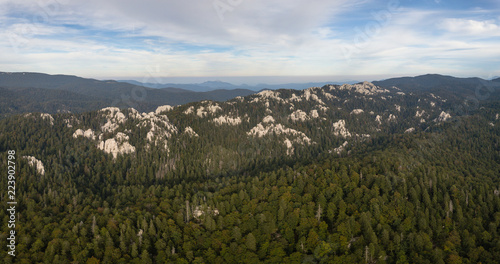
[{"left": 119, "top": 80, "right": 359, "bottom": 92}]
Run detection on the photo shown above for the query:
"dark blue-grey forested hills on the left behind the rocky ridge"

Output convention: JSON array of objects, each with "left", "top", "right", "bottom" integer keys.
[{"left": 0, "top": 72, "right": 254, "bottom": 114}]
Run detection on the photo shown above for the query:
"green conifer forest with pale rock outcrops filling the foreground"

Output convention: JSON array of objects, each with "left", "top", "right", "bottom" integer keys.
[{"left": 0, "top": 83, "right": 500, "bottom": 263}]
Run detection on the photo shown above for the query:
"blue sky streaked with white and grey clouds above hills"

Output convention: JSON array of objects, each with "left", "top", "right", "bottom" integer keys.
[{"left": 0, "top": 0, "right": 500, "bottom": 84}]
